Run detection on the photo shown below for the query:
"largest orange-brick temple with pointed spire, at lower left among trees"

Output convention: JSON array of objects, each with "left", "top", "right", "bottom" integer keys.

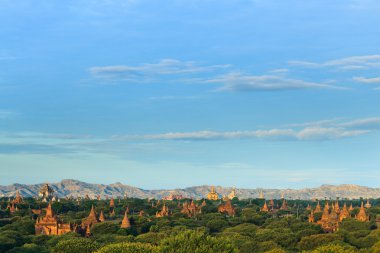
[{"left": 35, "top": 203, "right": 72, "bottom": 235}]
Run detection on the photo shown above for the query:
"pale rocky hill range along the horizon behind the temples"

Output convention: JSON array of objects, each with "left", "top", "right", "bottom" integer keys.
[{"left": 0, "top": 179, "right": 380, "bottom": 199}]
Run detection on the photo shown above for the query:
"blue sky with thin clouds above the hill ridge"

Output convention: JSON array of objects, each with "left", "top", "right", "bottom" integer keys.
[{"left": 0, "top": 0, "right": 380, "bottom": 189}]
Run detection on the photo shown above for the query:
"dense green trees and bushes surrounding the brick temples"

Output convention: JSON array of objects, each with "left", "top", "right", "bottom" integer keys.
[{"left": 0, "top": 198, "right": 380, "bottom": 253}]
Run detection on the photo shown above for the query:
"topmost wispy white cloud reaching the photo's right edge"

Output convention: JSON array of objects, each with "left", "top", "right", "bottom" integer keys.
[{"left": 288, "top": 55, "right": 380, "bottom": 70}]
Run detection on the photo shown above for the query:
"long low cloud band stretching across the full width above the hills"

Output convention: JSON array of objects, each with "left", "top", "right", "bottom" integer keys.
[{"left": 0, "top": 117, "right": 380, "bottom": 155}]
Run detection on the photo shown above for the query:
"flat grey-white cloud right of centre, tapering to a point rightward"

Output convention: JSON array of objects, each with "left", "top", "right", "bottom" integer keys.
[{"left": 205, "top": 73, "right": 344, "bottom": 91}]
